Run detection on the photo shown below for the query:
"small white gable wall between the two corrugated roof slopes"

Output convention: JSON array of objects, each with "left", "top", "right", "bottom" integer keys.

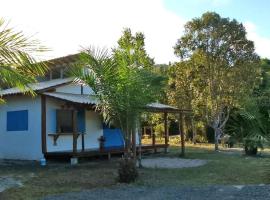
[{"left": 56, "top": 83, "right": 93, "bottom": 94}]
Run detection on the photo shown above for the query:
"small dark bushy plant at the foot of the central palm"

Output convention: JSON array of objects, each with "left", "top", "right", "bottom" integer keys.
[{"left": 118, "top": 156, "right": 138, "bottom": 183}]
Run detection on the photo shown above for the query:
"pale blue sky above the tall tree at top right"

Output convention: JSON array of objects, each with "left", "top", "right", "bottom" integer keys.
[{"left": 164, "top": 0, "right": 270, "bottom": 37}]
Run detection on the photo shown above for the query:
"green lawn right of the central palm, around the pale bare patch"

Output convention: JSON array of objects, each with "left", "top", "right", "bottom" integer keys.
[{"left": 137, "top": 147, "right": 270, "bottom": 185}]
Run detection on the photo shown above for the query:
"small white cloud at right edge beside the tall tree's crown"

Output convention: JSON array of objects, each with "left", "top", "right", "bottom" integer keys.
[{"left": 244, "top": 22, "right": 270, "bottom": 58}]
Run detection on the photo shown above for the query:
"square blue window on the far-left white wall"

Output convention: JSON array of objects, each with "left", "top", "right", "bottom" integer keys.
[{"left": 7, "top": 110, "right": 28, "bottom": 131}]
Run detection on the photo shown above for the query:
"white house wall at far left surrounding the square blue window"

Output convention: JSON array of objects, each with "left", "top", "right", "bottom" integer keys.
[{"left": 0, "top": 95, "right": 43, "bottom": 160}]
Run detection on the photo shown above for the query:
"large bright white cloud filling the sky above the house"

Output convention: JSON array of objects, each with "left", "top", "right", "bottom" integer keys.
[{"left": 0, "top": 0, "right": 184, "bottom": 63}]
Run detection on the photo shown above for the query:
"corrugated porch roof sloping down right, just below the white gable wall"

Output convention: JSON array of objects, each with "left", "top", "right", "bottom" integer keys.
[{"left": 43, "top": 92, "right": 98, "bottom": 104}]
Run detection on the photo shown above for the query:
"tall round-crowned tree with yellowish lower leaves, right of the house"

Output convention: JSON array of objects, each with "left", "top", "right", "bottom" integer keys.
[{"left": 174, "top": 12, "right": 259, "bottom": 150}]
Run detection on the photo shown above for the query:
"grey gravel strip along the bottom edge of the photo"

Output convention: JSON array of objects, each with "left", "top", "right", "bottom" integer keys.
[{"left": 43, "top": 185, "right": 270, "bottom": 200}]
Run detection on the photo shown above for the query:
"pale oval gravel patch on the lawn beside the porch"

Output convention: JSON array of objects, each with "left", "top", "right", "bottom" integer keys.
[{"left": 142, "top": 157, "right": 207, "bottom": 168}]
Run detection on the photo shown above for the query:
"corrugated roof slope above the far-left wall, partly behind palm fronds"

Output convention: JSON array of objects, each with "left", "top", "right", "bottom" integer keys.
[{"left": 0, "top": 78, "right": 74, "bottom": 96}]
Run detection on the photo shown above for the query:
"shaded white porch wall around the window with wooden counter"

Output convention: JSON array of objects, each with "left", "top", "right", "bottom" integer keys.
[{"left": 46, "top": 97, "right": 103, "bottom": 152}]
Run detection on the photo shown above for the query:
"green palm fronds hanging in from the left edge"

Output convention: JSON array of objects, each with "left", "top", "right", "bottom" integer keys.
[{"left": 0, "top": 19, "right": 47, "bottom": 100}]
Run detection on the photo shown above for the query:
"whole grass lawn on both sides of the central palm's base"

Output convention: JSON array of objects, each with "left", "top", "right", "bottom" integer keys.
[{"left": 0, "top": 146, "right": 270, "bottom": 200}]
